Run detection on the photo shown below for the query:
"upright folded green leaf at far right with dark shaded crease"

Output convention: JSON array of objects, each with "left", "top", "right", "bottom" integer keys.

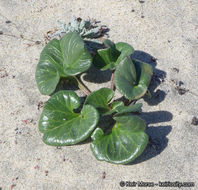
[{"left": 114, "top": 57, "right": 153, "bottom": 100}]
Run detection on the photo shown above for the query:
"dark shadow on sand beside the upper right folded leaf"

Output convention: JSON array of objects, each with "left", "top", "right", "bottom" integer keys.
[{"left": 131, "top": 50, "right": 166, "bottom": 105}]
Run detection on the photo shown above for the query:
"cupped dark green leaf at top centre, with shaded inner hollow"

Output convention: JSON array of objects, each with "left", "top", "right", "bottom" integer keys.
[{"left": 93, "top": 40, "right": 134, "bottom": 70}]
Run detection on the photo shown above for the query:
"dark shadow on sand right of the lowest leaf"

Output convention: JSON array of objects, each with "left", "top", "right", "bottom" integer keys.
[{"left": 127, "top": 111, "right": 173, "bottom": 165}]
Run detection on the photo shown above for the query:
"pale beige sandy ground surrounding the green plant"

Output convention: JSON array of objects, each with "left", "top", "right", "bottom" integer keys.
[{"left": 0, "top": 0, "right": 198, "bottom": 190}]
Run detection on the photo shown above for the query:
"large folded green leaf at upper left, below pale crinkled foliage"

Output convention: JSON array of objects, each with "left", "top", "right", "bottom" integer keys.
[{"left": 35, "top": 33, "right": 92, "bottom": 95}]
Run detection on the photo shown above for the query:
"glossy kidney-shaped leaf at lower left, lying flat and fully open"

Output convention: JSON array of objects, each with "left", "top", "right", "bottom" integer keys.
[{"left": 39, "top": 91, "right": 99, "bottom": 146}]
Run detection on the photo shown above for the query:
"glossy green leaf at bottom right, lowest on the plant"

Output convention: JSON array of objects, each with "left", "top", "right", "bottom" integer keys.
[{"left": 91, "top": 116, "right": 148, "bottom": 164}]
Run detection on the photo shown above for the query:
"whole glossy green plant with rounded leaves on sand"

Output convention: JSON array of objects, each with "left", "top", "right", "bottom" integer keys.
[{"left": 36, "top": 23, "right": 152, "bottom": 164}]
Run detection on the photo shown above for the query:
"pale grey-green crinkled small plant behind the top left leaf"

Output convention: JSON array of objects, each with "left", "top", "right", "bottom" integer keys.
[{"left": 53, "top": 17, "right": 107, "bottom": 39}]
